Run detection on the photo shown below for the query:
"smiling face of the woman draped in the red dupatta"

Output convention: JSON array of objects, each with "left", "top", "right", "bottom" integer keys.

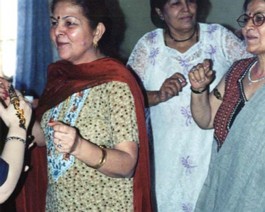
[{"left": 50, "top": 1, "right": 100, "bottom": 64}]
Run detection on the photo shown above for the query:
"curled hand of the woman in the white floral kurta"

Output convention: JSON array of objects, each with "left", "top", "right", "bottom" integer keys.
[{"left": 159, "top": 73, "right": 187, "bottom": 102}]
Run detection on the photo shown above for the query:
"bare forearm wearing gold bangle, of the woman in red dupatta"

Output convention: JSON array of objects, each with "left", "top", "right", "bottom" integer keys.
[{"left": 73, "top": 140, "right": 138, "bottom": 178}]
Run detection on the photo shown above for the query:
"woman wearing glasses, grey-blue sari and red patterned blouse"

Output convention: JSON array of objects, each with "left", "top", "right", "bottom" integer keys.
[{"left": 189, "top": 0, "right": 265, "bottom": 212}]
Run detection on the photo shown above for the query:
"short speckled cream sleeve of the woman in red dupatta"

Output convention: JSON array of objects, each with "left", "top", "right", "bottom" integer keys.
[{"left": 106, "top": 82, "right": 139, "bottom": 145}]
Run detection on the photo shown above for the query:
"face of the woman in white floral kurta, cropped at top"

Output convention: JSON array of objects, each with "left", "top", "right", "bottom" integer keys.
[{"left": 156, "top": 0, "right": 197, "bottom": 32}]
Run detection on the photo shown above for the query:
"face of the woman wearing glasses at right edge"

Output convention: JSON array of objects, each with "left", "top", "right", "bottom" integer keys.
[{"left": 242, "top": 0, "right": 265, "bottom": 55}]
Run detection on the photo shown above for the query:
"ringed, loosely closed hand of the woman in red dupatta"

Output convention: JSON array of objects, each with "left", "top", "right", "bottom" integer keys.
[{"left": 48, "top": 121, "right": 81, "bottom": 154}]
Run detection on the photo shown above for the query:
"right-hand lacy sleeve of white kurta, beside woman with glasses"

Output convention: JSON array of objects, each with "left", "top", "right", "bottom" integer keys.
[{"left": 221, "top": 27, "right": 253, "bottom": 65}]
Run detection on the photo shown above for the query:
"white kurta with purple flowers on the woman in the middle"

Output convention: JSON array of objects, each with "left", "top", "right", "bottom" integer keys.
[{"left": 128, "top": 24, "right": 250, "bottom": 212}]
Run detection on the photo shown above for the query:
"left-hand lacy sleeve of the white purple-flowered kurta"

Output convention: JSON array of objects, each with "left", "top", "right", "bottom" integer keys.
[{"left": 127, "top": 35, "right": 150, "bottom": 82}]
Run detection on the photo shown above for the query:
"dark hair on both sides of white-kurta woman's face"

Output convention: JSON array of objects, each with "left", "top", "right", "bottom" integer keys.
[{"left": 150, "top": 0, "right": 211, "bottom": 28}]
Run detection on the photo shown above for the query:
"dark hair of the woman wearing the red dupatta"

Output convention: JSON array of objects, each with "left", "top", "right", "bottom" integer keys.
[{"left": 51, "top": 0, "right": 118, "bottom": 56}]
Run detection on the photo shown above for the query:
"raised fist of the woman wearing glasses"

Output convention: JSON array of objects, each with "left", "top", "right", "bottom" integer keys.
[{"left": 189, "top": 60, "right": 214, "bottom": 91}]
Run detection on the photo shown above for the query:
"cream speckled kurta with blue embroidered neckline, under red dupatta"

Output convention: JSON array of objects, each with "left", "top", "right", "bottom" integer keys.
[{"left": 41, "top": 82, "right": 139, "bottom": 212}]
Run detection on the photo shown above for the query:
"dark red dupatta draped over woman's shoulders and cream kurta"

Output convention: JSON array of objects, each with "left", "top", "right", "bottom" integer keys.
[{"left": 17, "top": 58, "right": 152, "bottom": 212}]
